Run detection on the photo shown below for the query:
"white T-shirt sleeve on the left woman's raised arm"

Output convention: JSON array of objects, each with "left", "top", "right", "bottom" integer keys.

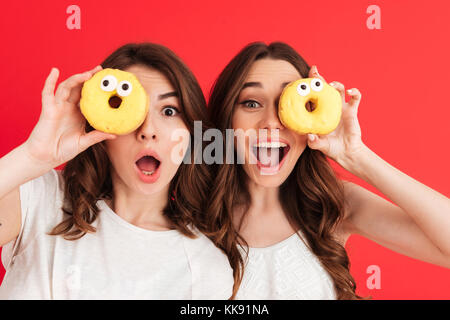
[{"left": 2, "top": 170, "right": 63, "bottom": 269}]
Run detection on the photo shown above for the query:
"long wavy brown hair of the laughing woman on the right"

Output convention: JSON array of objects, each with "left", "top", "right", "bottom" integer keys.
[{"left": 207, "top": 42, "right": 368, "bottom": 299}]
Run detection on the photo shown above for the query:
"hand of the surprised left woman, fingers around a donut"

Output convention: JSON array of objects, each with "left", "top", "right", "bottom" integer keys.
[{"left": 24, "top": 66, "right": 115, "bottom": 169}]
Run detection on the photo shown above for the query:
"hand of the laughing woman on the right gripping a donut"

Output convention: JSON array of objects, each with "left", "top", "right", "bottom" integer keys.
[{"left": 308, "top": 66, "right": 365, "bottom": 171}]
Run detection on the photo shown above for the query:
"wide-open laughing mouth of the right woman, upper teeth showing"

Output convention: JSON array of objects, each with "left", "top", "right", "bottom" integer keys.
[{"left": 252, "top": 141, "right": 290, "bottom": 168}]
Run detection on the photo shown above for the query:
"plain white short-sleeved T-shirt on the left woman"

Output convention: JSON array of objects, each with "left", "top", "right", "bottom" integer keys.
[{"left": 0, "top": 170, "right": 233, "bottom": 299}]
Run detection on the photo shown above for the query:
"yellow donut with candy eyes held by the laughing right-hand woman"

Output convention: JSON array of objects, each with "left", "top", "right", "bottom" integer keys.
[{"left": 278, "top": 78, "right": 342, "bottom": 134}]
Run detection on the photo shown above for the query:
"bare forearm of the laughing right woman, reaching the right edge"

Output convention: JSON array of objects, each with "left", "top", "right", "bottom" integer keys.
[{"left": 346, "top": 147, "right": 450, "bottom": 256}]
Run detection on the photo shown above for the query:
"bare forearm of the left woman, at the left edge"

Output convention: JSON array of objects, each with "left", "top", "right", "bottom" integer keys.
[{"left": 0, "top": 144, "right": 52, "bottom": 199}]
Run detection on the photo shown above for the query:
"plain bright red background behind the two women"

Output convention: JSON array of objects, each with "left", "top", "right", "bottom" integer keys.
[{"left": 0, "top": 0, "right": 450, "bottom": 299}]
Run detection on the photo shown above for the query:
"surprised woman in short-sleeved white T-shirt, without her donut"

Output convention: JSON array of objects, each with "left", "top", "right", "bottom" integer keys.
[{"left": 0, "top": 43, "right": 233, "bottom": 299}]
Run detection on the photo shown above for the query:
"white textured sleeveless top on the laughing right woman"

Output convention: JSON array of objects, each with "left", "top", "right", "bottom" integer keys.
[{"left": 236, "top": 231, "right": 336, "bottom": 300}]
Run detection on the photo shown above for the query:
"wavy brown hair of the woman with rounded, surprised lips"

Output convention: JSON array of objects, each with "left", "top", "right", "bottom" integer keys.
[{"left": 49, "top": 43, "right": 211, "bottom": 240}]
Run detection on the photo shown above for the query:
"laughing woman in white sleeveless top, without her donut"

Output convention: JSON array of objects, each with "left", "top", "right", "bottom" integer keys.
[{"left": 207, "top": 42, "right": 450, "bottom": 299}]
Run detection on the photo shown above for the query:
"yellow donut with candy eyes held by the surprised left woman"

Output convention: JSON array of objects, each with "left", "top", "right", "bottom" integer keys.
[{"left": 80, "top": 69, "right": 148, "bottom": 135}]
